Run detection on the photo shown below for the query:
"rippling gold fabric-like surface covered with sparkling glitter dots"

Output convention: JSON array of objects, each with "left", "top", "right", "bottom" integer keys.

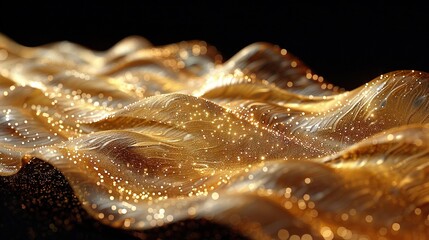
[{"left": 0, "top": 36, "right": 429, "bottom": 239}]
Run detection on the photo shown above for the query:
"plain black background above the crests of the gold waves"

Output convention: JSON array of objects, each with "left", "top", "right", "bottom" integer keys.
[{"left": 0, "top": 0, "right": 429, "bottom": 89}]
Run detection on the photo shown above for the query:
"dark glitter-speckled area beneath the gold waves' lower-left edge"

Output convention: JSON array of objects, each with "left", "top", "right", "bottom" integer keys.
[{"left": 0, "top": 160, "right": 246, "bottom": 240}]
